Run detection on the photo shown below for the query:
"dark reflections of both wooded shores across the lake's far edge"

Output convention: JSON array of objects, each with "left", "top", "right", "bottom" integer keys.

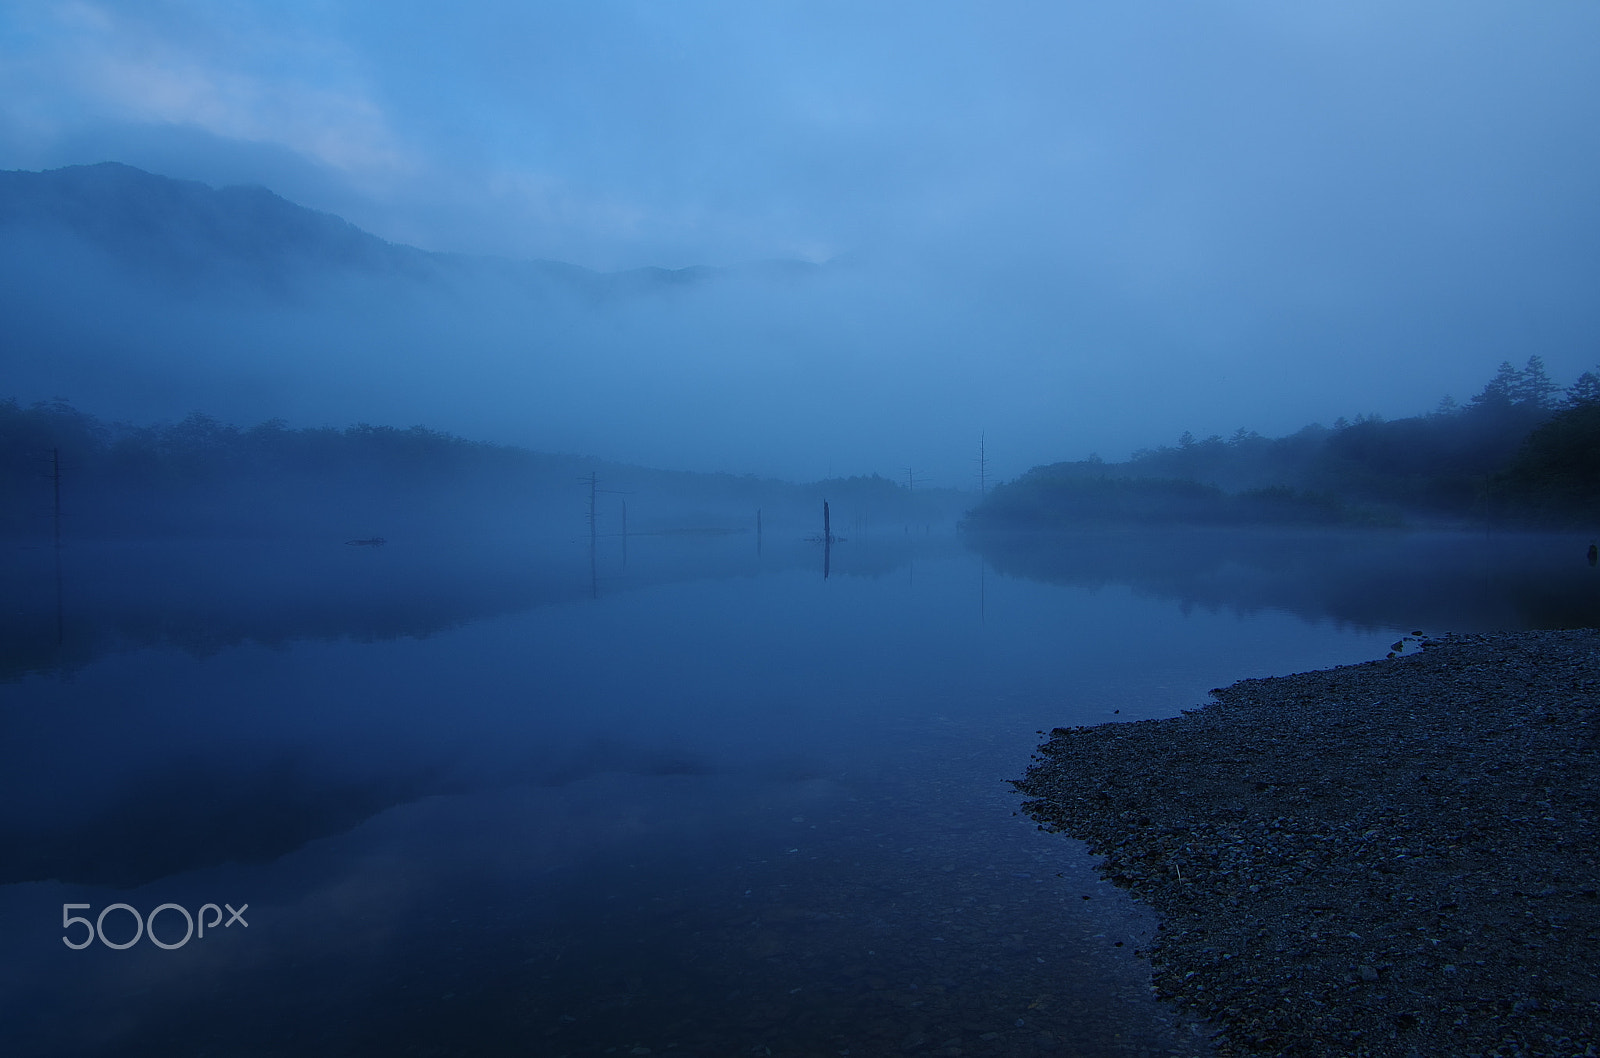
[{"left": 9, "top": 528, "right": 1600, "bottom": 680}]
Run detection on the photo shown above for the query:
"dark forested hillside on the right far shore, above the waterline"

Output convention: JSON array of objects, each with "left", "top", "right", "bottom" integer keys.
[{"left": 966, "top": 357, "right": 1600, "bottom": 528}]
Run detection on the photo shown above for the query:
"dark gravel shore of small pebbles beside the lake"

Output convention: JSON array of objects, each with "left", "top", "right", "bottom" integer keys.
[{"left": 1018, "top": 631, "right": 1600, "bottom": 1056}]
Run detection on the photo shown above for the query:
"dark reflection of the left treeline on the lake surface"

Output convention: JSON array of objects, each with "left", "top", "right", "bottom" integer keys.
[{"left": 0, "top": 535, "right": 940, "bottom": 680}]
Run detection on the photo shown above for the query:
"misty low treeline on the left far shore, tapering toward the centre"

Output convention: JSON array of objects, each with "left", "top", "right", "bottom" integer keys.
[{"left": 0, "top": 400, "right": 966, "bottom": 539}]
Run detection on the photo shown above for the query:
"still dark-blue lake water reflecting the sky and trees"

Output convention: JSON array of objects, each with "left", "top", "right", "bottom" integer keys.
[{"left": 0, "top": 533, "right": 1600, "bottom": 1056}]
